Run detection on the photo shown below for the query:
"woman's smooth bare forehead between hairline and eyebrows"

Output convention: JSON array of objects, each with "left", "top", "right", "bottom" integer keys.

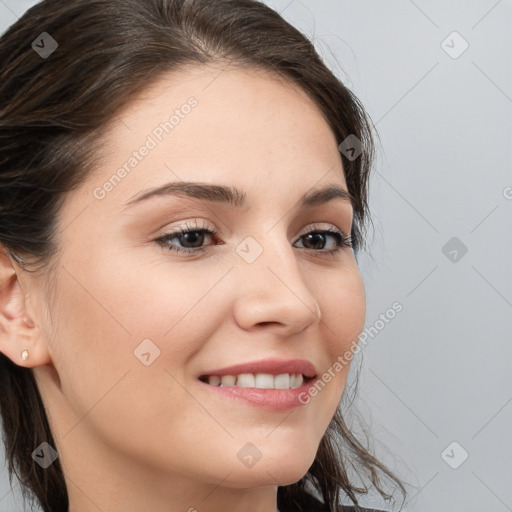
[{"left": 85, "top": 66, "right": 346, "bottom": 212}]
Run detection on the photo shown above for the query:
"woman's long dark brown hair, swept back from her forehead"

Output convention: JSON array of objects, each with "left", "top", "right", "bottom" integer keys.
[{"left": 0, "top": 0, "right": 406, "bottom": 512}]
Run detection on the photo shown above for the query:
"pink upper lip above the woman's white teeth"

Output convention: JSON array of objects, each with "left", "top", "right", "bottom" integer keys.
[{"left": 201, "top": 359, "right": 316, "bottom": 378}]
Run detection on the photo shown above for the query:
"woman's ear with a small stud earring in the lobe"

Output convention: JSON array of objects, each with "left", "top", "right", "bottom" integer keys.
[{"left": 0, "top": 246, "right": 51, "bottom": 368}]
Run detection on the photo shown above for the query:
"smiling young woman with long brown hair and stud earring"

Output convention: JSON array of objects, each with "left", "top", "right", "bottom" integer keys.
[{"left": 0, "top": 0, "right": 405, "bottom": 512}]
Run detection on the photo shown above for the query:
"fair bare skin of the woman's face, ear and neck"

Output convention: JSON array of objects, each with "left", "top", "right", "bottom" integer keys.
[{"left": 0, "top": 66, "right": 365, "bottom": 512}]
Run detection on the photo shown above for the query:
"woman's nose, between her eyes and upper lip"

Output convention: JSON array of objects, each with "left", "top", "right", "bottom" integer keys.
[{"left": 234, "top": 234, "right": 321, "bottom": 336}]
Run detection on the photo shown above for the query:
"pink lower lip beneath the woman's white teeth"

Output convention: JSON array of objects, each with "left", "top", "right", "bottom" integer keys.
[{"left": 199, "top": 378, "right": 314, "bottom": 412}]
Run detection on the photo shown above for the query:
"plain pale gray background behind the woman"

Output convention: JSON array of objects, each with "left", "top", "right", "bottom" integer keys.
[{"left": 0, "top": 0, "right": 512, "bottom": 512}]
